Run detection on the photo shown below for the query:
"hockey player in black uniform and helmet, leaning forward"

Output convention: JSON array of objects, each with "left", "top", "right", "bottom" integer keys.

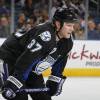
[{"left": 0, "top": 7, "right": 78, "bottom": 100}]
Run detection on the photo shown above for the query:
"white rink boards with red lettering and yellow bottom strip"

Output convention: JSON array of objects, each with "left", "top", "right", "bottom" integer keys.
[{"left": 0, "top": 39, "right": 100, "bottom": 76}]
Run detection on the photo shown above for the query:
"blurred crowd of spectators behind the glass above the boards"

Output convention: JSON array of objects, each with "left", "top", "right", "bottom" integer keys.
[{"left": 0, "top": 0, "right": 100, "bottom": 40}]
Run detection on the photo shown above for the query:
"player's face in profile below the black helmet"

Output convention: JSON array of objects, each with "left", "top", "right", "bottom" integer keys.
[{"left": 58, "top": 22, "right": 74, "bottom": 38}]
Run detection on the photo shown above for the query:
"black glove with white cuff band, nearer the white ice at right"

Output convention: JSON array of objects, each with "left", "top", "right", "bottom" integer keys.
[{"left": 46, "top": 75, "right": 66, "bottom": 96}]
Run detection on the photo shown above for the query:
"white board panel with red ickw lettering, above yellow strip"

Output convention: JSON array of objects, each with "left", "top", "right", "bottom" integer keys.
[{"left": 66, "top": 40, "right": 100, "bottom": 68}]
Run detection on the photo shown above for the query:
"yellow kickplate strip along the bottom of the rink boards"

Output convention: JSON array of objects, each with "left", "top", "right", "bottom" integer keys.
[{"left": 43, "top": 68, "right": 100, "bottom": 76}]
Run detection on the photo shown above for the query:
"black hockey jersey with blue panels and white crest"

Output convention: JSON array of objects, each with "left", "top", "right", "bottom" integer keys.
[{"left": 0, "top": 22, "right": 73, "bottom": 80}]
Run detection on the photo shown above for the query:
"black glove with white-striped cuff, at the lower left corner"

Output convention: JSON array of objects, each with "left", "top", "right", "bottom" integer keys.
[{"left": 2, "top": 76, "right": 23, "bottom": 100}]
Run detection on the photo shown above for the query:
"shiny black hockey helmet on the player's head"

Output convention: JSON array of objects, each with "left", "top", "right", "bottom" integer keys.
[{"left": 53, "top": 7, "right": 79, "bottom": 25}]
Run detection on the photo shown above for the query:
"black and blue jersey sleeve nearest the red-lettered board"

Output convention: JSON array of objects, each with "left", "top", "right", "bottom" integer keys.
[{"left": 52, "top": 38, "right": 73, "bottom": 77}]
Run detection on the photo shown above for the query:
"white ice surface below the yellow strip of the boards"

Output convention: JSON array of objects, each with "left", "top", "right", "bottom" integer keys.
[{"left": 0, "top": 77, "right": 100, "bottom": 100}]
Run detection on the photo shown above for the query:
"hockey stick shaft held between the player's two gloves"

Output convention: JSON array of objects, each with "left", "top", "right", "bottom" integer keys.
[{"left": 16, "top": 87, "right": 49, "bottom": 93}]
